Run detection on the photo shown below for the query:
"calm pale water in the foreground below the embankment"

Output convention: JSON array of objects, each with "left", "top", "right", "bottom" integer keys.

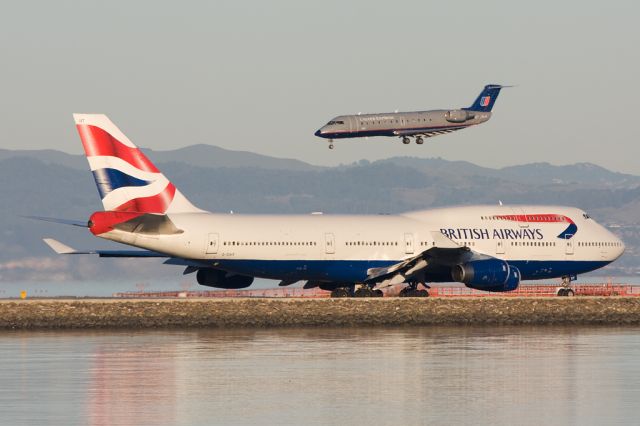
[{"left": 0, "top": 327, "right": 640, "bottom": 425}]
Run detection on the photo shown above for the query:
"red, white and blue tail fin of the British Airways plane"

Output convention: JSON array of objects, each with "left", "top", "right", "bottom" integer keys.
[{"left": 73, "top": 114, "right": 202, "bottom": 214}]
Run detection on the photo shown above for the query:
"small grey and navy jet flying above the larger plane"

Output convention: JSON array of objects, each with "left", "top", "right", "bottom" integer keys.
[{"left": 315, "top": 84, "right": 509, "bottom": 149}]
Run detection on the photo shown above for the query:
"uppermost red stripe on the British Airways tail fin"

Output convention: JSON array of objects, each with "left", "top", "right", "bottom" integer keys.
[{"left": 76, "top": 124, "right": 160, "bottom": 173}]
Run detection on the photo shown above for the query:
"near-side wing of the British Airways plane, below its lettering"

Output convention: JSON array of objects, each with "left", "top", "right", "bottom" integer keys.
[{"left": 365, "top": 231, "right": 490, "bottom": 288}]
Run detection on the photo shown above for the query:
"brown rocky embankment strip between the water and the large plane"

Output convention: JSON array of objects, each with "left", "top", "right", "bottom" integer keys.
[{"left": 0, "top": 297, "right": 640, "bottom": 330}]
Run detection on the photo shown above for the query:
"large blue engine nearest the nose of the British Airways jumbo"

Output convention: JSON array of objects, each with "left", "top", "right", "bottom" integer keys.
[{"left": 451, "top": 259, "right": 520, "bottom": 291}]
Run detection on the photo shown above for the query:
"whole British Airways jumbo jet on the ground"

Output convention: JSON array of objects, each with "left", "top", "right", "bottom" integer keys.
[{"left": 38, "top": 114, "right": 625, "bottom": 296}]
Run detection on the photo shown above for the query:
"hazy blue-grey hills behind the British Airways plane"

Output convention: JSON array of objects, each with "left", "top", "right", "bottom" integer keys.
[{"left": 0, "top": 145, "right": 640, "bottom": 282}]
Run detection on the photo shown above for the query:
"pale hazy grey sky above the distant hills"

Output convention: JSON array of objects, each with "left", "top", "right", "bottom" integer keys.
[{"left": 0, "top": 0, "right": 640, "bottom": 174}]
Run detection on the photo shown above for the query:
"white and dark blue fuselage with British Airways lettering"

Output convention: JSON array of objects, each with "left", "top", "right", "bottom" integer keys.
[{"left": 100, "top": 206, "right": 624, "bottom": 282}]
